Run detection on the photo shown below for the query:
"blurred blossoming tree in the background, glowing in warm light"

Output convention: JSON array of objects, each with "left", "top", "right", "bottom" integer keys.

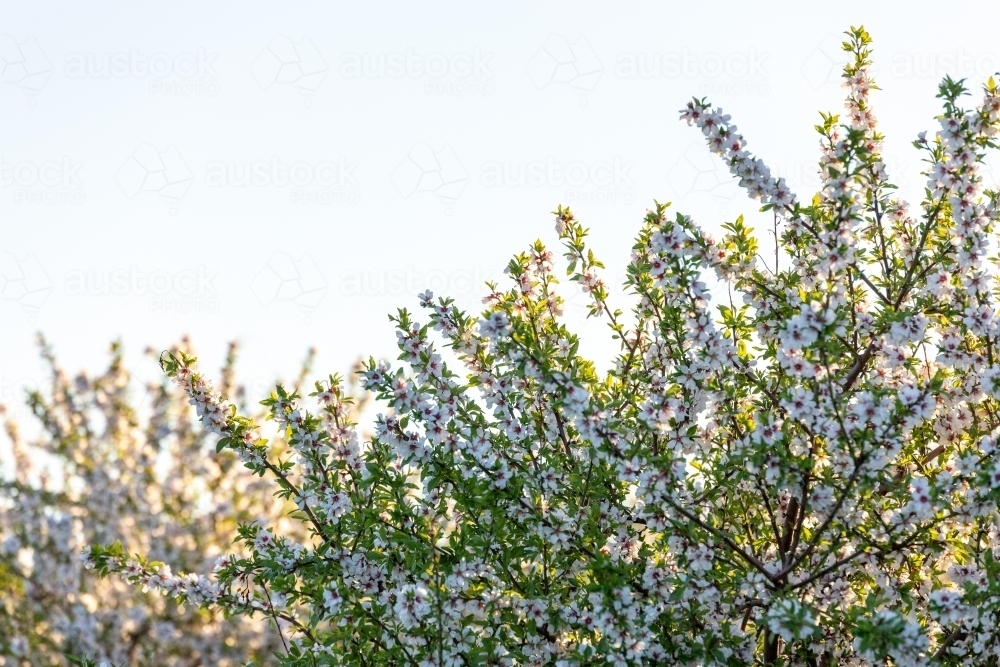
[{"left": 0, "top": 341, "right": 360, "bottom": 667}]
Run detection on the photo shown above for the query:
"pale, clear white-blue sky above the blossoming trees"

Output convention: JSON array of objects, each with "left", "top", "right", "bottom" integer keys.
[{"left": 0, "top": 0, "right": 1000, "bottom": 428}]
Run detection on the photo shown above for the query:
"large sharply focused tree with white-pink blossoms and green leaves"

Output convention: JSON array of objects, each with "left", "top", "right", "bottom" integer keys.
[{"left": 87, "top": 28, "right": 1000, "bottom": 667}]
